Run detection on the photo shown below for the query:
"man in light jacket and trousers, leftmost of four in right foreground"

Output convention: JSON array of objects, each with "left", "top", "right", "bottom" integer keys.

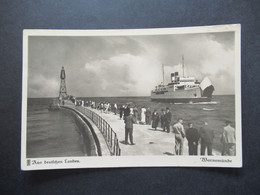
[{"left": 173, "top": 119, "right": 185, "bottom": 155}]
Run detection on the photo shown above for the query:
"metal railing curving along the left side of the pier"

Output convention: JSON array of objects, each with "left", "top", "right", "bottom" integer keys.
[{"left": 80, "top": 108, "right": 121, "bottom": 156}]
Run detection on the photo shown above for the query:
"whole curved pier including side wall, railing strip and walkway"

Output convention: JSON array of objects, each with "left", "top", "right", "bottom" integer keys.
[{"left": 62, "top": 101, "right": 219, "bottom": 156}]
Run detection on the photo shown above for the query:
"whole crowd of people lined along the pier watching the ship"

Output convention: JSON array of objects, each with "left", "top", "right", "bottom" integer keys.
[{"left": 71, "top": 97, "right": 236, "bottom": 156}]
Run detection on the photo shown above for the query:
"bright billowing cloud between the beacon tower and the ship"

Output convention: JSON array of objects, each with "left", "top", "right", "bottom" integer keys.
[{"left": 80, "top": 53, "right": 162, "bottom": 96}]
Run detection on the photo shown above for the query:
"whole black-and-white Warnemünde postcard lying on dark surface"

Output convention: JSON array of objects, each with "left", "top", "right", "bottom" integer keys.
[{"left": 21, "top": 24, "right": 242, "bottom": 170}]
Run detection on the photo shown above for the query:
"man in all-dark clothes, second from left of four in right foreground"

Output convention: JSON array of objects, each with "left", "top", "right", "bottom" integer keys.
[{"left": 186, "top": 123, "right": 199, "bottom": 155}]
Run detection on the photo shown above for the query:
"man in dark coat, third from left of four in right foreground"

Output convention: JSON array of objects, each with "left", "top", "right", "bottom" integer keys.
[{"left": 199, "top": 122, "right": 214, "bottom": 155}]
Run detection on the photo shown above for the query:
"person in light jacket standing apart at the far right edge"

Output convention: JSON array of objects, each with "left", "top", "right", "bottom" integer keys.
[{"left": 222, "top": 121, "right": 236, "bottom": 156}]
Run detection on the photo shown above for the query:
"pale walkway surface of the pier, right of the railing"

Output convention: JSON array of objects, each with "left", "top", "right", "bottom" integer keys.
[{"left": 76, "top": 106, "right": 188, "bottom": 156}]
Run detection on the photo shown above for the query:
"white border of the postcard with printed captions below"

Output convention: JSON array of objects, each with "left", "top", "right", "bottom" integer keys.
[{"left": 21, "top": 24, "right": 242, "bottom": 170}]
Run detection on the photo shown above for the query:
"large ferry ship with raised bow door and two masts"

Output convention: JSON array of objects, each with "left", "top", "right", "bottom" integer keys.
[{"left": 151, "top": 57, "right": 214, "bottom": 103}]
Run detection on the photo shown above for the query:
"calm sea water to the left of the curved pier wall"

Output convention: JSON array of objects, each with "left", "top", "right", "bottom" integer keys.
[{"left": 27, "top": 98, "right": 86, "bottom": 158}]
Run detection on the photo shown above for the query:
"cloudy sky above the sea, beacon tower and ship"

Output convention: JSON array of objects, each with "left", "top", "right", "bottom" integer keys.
[{"left": 28, "top": 32, "right": 235, "bottom": 97}]
